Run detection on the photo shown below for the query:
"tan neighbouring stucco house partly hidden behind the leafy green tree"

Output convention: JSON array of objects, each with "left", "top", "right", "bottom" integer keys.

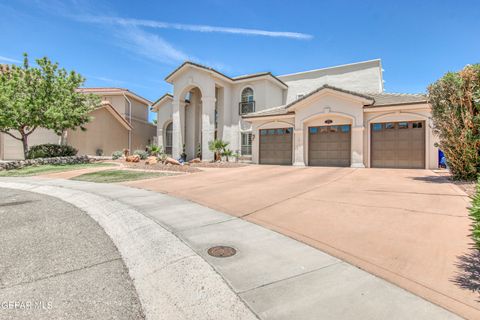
[{"left": 0, "top": 88, "right": 156, "bottom": 160}]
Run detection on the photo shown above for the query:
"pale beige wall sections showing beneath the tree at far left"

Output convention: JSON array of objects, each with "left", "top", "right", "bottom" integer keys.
[{"left": 0, "top": 128, "right": 59, "bottom": 160}]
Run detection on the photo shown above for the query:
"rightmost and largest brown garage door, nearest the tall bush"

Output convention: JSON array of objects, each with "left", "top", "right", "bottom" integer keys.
[{"left": 371, "top": 121, "right": 425, "bottom": 169}]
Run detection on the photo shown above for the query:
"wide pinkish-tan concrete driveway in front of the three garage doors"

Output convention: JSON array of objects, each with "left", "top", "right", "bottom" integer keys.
[{"left": 127, "top": 165, "right": 480, "bottom": 319}]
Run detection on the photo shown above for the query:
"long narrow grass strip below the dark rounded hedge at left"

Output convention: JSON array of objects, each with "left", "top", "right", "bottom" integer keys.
[{"left": 0, "top": 162, "right": 116, "bottom": 177}]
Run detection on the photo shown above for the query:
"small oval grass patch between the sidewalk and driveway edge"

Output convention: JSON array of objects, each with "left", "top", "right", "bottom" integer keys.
[{"left": 72, "top": 170, "right": 174, "bottom": 183}]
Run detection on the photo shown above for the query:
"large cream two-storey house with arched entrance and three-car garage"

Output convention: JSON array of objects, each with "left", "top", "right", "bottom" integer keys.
[{"left": 153, "top": 60, "right": 438, "bottom": 168}]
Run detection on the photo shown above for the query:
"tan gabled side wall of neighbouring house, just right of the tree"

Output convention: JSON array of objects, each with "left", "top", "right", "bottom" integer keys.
[{"left": 67, "top": 108, "right": 128, "bottom": 156}]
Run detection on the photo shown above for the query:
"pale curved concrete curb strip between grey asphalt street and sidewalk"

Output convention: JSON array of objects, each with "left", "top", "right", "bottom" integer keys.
[{"left": 0, "top": 182, "right": 257, "bottom": 319}]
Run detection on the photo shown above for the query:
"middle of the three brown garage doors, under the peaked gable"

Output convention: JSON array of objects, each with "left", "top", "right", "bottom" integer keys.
[{"left": 308, "top": 125, "right": 351, "bottom": 167}]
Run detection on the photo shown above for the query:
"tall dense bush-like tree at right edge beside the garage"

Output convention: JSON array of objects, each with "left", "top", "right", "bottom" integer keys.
[{"left": 428, "top": 64, "right": 480, "bottom": 180}]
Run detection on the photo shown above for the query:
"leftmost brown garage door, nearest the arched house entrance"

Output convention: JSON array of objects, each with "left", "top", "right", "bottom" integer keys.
[{"left": 260, "top": 128, "right": 293, "bottom": 164}]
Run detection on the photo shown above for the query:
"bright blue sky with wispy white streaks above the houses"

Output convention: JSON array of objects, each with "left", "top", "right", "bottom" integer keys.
[{"left": 0, "top": 0, "right": 480, "bottom": 122}]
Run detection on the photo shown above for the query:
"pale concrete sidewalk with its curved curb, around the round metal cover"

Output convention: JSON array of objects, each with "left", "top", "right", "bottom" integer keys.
[{"left": 0, "top": 178, "right": 458, "bottom": 319}]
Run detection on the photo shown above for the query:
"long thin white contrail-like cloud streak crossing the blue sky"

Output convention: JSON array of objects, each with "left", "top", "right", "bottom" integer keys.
[{"left": 77, "top": 16, "right": 313, "bottom": 40}]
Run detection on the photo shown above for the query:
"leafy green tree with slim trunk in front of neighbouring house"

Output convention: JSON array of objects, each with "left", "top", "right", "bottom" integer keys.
[{"left": 0, "top": 54, "right": 99, "bottom": 158}]
